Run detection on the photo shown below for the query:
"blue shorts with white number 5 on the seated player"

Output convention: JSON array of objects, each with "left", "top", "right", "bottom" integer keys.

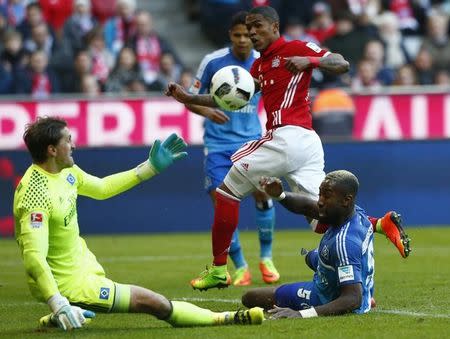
[{"left": 275, "top": 281, "right": 322, "bottom": 311}]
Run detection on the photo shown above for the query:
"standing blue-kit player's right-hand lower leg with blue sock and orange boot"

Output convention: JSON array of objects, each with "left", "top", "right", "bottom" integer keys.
[{"left": 253, "top": 191, "right": 280, "bottom": 284}]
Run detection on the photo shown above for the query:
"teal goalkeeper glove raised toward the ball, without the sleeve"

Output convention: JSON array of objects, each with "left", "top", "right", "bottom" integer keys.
[{"left": 148, "top": 133, "right": 187, "bottom": 173}]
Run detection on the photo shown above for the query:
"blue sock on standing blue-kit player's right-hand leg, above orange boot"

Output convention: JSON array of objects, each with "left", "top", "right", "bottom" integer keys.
[{"left": 256, "top": 200, "right": 275, "bottom": 258}]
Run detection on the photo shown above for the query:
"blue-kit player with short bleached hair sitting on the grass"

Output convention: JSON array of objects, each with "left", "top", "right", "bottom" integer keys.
[{"left": 242, "top": 170, "right": 375, "bottom": 318}]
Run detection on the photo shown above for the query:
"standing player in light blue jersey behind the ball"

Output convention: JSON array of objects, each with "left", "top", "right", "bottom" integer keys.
[{"left": 186, "top": 12, "right": 280, "bottom": 286}]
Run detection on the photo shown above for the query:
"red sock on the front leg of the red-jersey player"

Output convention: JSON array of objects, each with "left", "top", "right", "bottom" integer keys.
[{"left": 212, "top": 188, "right": 240, "bottom": 266}]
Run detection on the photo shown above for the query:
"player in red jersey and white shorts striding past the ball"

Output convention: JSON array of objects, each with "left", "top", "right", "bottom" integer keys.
[{"left": 166, "top": 6, "right": 409, "bottom": 290}]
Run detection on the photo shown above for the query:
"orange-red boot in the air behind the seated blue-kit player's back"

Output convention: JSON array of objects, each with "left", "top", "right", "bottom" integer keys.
[{"left": 381, "top": 211, "right": 411, "bottom": 258}]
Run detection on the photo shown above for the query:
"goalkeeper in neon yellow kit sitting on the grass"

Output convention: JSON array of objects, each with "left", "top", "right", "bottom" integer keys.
[{"left": 14, "top": 117, "right": 263, "bottom": 330}]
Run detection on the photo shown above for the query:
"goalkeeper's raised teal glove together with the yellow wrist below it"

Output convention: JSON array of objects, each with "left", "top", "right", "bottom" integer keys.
[{"left": 136, "top": 133, "right": 187, "bottom": 180}]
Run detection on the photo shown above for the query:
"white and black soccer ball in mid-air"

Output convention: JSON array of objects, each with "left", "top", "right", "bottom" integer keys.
[{"left": 209, "top": 66, "right": 255, "bottom": 111}]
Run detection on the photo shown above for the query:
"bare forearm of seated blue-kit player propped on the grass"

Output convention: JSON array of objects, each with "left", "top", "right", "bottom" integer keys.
[{"left": 314, "top": 283, "right": 362, "bottom": 316}]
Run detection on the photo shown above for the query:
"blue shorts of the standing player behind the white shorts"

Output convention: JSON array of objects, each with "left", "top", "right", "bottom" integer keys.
[{"left": 204, "top": 150, "right": 236, "bottom": 193}]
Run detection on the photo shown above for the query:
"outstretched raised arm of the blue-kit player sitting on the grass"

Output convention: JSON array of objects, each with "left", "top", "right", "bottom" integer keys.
[{"left": 259, "top": 177, "right": 319, "bottom": 219}]
